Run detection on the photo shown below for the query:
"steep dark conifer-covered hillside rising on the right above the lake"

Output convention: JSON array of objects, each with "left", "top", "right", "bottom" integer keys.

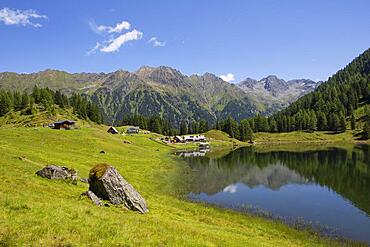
[{"left": 274, "top": 49, "right": 370, "bottom": 132}]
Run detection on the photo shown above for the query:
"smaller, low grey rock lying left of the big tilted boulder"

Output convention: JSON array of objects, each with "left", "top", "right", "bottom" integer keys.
[{"left": 36, "top": 165, "right": 77, "bottom": 183}]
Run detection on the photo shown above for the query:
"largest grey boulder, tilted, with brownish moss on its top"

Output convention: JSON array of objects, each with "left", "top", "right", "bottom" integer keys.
[{"left": 89, "top": 164, "right": 149, "bottom": 213}]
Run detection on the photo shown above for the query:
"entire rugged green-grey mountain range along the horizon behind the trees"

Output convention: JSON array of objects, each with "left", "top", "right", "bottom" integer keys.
[{"left": 0, "top": 66, "right": 318, "bottom": 125}]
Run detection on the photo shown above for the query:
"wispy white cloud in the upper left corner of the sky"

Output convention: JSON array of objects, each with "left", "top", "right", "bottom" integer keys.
[{"left": 0, "top": 8, "right": 47, "bottom": 27}]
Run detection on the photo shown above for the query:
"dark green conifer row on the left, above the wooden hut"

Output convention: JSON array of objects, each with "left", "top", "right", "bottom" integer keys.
[{"left": 0, "top": 86, "right": 102, "bottom": 123}]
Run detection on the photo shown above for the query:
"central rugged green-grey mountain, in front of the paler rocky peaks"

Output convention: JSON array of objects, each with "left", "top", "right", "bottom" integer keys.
[{"left": 92, "top": 66, "right": 257, "bottom": 124}]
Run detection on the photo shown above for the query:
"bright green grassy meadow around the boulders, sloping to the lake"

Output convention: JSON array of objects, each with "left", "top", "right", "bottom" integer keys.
[{"left": 0, "top": 127, "right": 346, "bottom": 246}]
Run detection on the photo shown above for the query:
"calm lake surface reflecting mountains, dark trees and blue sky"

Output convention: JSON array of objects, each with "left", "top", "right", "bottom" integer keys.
[{"left": 181, "top": 145, "right": 370, "bottom": 244}]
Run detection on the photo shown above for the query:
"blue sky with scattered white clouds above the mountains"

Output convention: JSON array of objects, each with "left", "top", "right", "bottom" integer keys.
[{"left": 0, "top": 0, "right": 370, "bottom": 81}]
